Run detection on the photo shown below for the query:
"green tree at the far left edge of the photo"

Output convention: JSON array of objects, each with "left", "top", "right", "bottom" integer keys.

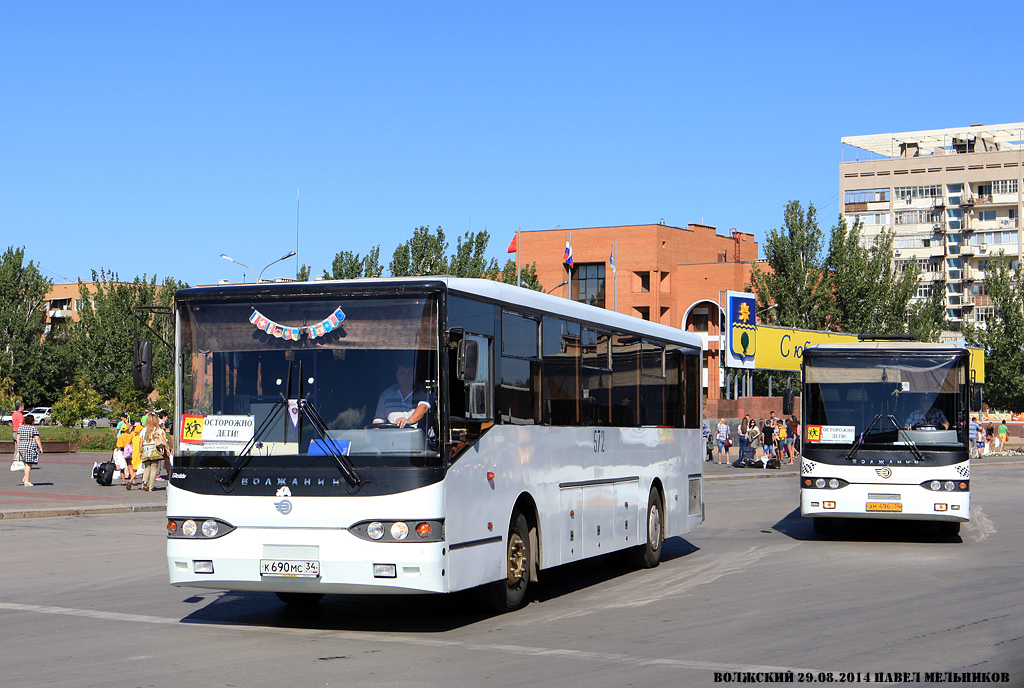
[{"left": 0, "top": 247, "right": 53, "bottom": 401}]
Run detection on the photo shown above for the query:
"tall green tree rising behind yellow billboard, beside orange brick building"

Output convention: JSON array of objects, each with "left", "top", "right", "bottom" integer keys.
[{"left": 750, "top": 201, "right": 831, "bottom": 330}]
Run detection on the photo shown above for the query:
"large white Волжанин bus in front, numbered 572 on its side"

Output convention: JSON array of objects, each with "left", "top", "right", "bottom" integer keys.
[{"left": 167, "top": 277, "right": 703, "bottom": 611}]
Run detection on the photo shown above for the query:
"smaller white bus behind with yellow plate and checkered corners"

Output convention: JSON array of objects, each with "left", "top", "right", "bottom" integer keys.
[{"left": 800, "top": 337, "right": 974, "bottom": 534}]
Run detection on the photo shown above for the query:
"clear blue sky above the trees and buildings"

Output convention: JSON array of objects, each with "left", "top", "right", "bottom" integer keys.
[{"left": 0, "top": 1, "right": 1024, "bottom": 285}]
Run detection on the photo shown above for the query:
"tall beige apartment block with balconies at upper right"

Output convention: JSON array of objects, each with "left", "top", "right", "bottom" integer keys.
[{"left": 840, "top": 123, "right": 1024, "bottom": 327}]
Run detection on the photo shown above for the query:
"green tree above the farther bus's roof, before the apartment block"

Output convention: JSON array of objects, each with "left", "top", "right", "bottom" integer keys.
[{"left": 822, "top": 215, "right": 919, "bottom": 335}]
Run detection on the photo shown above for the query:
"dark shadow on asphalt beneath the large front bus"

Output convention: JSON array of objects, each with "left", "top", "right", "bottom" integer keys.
[{"left": 181, "top": 538, "right": 699, "bottom": 633}]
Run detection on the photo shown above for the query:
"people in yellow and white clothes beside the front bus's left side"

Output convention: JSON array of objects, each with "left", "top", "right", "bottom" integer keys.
[{"left": 113, "top": 411, "right": 172, "bottom": 491}]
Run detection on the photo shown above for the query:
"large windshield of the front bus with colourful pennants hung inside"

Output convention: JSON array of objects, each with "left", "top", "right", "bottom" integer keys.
[{"left": 175, "top": 295, "right": 440, "bottom": 468}]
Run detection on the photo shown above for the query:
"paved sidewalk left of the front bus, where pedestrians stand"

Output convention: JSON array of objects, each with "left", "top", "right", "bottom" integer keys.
[{"left": 0, "top": 452, "right": 167, "bottom": 519}]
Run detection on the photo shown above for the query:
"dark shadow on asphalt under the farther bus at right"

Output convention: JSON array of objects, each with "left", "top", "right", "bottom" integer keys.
[{"left": 772, "top": 509, "right": 964, "bottom": 543}]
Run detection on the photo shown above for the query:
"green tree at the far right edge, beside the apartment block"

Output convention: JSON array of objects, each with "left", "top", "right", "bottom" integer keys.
[{"left": 965, "top": 252, "right": 1024, "bottom": 412}]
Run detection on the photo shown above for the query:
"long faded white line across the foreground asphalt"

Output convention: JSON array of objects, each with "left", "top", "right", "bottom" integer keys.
[{"left": 0, "top": 602, "right": 822, "bottom": 674}]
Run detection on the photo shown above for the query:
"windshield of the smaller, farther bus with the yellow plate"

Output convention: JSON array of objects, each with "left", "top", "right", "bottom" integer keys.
[{"left": 804, "top": 353, "right": 968, "bottom": 446}]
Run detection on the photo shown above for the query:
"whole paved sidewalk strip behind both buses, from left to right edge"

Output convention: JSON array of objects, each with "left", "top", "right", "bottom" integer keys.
[{"left": 0, "top": 448, "right": 1024, "bottom": 519}]
